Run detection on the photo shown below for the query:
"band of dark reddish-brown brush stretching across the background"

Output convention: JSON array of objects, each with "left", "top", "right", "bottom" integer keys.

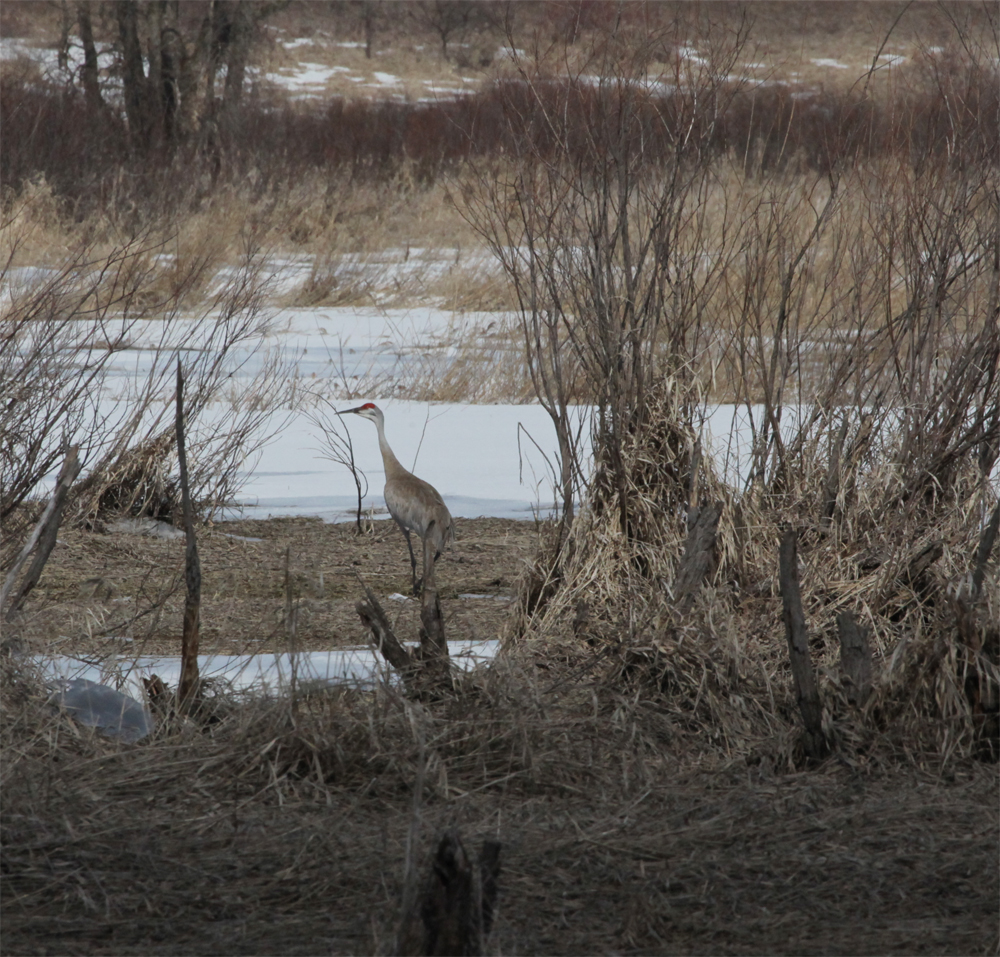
[{"left": 0, "top": 61, "right": 1000, "bottom": 208}]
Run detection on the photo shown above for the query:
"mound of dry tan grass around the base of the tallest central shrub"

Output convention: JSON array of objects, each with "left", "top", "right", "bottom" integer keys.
[{"left": 504, "top": 380, "right": 776, "bottom": 755}]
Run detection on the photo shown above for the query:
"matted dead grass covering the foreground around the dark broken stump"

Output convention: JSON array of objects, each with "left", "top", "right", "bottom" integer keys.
[{"left": 0, "top": 655, "right": 998, "bottom": 954}]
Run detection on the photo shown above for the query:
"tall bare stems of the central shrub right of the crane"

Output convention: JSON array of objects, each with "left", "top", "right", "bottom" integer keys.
[{"left": 467, "top": 16, "right": 746, "bottom": 529}]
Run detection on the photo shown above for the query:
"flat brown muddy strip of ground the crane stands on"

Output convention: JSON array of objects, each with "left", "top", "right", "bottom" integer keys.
[{"left": 11, "top": 518, "right": 537, "bottom": 656}]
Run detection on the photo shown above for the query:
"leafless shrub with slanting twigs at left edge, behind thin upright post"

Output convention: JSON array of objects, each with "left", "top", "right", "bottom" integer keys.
[{"left": 0, "top": 226, "right": 286, "bottom": 560}]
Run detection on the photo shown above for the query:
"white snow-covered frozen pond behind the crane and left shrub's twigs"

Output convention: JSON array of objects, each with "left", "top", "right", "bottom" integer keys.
[{"left": 19, "top": 296, "right": 776, "bottom": 522}]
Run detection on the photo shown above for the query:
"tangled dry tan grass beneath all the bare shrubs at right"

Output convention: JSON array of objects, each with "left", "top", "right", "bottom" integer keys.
[{"left": 511, "top": 378, "right": 1000, "bottom": 767}]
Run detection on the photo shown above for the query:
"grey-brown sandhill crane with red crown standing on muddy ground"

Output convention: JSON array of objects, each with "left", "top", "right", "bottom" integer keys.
[{"left": 340, "top": 402, "right": 455, "bottom": 594}]
